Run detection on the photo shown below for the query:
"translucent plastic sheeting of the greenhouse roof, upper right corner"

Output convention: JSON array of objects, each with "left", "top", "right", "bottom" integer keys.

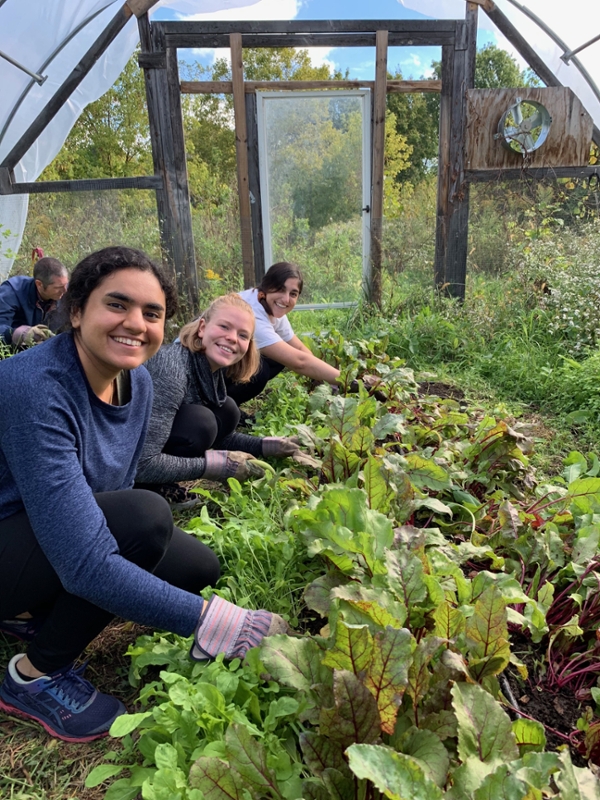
[{"left": 400, "top": 0, "right": 600, "bottom": 127}]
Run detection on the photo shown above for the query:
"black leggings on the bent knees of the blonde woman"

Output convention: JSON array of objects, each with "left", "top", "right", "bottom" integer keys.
[{"left": 163, "top": 397, "right": 240, "bottom": 458}]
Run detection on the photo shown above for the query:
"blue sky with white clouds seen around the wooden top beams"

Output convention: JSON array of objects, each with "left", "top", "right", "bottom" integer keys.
[{"left": 153, "top": 0, "right": 495, "bottom": 80}]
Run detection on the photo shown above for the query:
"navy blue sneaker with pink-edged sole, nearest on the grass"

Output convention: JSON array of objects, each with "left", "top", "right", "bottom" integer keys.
[{"left": 0, "top": 653, "right": 125, "bottom": 742}]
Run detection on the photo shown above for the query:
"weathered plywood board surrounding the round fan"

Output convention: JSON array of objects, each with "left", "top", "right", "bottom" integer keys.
[{"left": 465, "top": 86, "right": 593, "bottom": 170}]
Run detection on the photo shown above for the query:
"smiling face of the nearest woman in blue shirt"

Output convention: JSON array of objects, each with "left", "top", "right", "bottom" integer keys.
[{"left": 71, "top": 267, "right": 165, "bottom": 399}]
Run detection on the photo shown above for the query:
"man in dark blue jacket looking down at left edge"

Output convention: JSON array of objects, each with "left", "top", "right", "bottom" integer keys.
[{"left": 0, "top": 253, "right": 69, "bottom": 347}]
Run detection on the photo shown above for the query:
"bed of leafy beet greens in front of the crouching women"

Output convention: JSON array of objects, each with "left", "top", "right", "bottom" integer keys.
[{"left": 88, "top": 331, "right": 600, "bottom": 800}]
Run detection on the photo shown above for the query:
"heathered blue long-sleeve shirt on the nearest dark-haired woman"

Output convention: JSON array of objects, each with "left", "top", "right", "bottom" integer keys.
[{"left": 0, "top": 333, "right": 203, "bottom": 636}]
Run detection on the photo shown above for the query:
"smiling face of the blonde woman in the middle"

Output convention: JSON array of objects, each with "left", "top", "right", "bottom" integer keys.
[{"left": 198, "top": 306, "right": 254, "bottom": 372}]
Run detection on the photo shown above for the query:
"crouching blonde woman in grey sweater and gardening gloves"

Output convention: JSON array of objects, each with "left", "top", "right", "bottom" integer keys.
[{"left": 136, "top": 293, "right": 299, "bottom": 508}]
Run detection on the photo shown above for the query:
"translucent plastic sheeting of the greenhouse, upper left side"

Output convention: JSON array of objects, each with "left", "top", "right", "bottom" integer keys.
[{"left": 0, "top": 0, "right": 257, "bottom": 280}]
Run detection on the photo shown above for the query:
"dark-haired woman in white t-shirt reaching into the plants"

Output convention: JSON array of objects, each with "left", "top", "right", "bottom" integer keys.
[{"left": 227, "top": 261, "right": 340, "bottom": 406}]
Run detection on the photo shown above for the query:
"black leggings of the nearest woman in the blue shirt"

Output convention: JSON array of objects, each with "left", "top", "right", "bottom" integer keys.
[{"left": 0, "top": 489, "right": 220, "bottom": 672}]
